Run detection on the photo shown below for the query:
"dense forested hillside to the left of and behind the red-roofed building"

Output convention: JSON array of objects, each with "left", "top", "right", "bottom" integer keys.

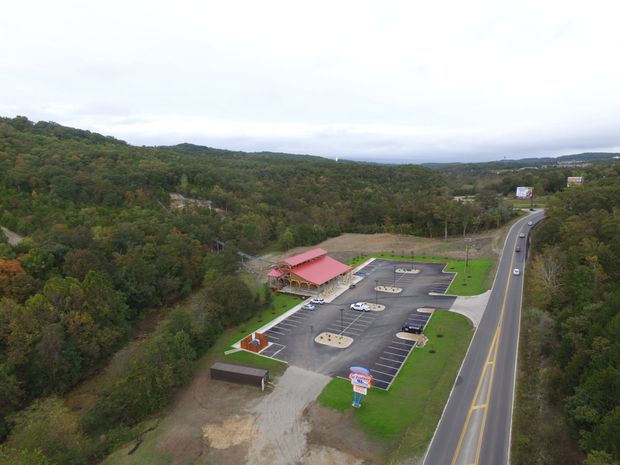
[{"left": 0, "top": 117, "right": 515, "bottom": 448}]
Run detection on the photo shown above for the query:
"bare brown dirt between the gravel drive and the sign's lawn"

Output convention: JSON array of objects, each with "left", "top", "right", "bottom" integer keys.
[{"left": 302, "top": 402, "right": 389, "bottom": 464}]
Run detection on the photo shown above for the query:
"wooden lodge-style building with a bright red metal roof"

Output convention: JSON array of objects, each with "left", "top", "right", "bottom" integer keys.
[{"left": 267, "top": 249, "right": 352, "bottom": 295}]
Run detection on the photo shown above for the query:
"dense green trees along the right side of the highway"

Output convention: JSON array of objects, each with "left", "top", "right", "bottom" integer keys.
[{"left": 515, "top": 166, "right": 620, "bottom": 465}]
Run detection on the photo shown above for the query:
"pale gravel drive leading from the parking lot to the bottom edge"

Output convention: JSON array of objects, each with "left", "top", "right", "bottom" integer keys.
[{"left": 247, "top": 366, "right": 331, "bottom": 465}]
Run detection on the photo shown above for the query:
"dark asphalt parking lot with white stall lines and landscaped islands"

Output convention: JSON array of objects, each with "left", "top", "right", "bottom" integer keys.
[{"left": 261, "top": 260, "right": 454, "bottom": 389}]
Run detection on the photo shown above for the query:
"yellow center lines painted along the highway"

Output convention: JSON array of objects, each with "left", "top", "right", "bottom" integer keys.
[{"left": 451, "top": 227, "right": 514, "bottom": 465}]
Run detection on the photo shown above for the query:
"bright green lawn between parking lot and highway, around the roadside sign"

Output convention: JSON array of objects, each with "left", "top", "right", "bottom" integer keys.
[{"left": 318, "top": 311, "right": 473, "bottom": 460}]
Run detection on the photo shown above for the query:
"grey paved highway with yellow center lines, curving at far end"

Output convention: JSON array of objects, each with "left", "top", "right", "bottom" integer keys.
[{"left": 423, "top": 210, "right": 544, "bottom": 465}]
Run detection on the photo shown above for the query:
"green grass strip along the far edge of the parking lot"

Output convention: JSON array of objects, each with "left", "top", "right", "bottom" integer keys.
[{"left": 347, "top": 254, "right": 493, "bottom": 296}]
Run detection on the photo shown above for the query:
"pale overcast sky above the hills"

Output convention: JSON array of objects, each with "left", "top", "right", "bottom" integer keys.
[{"left": 0, "top": 0, "right": 620, "bottom": 162}]
